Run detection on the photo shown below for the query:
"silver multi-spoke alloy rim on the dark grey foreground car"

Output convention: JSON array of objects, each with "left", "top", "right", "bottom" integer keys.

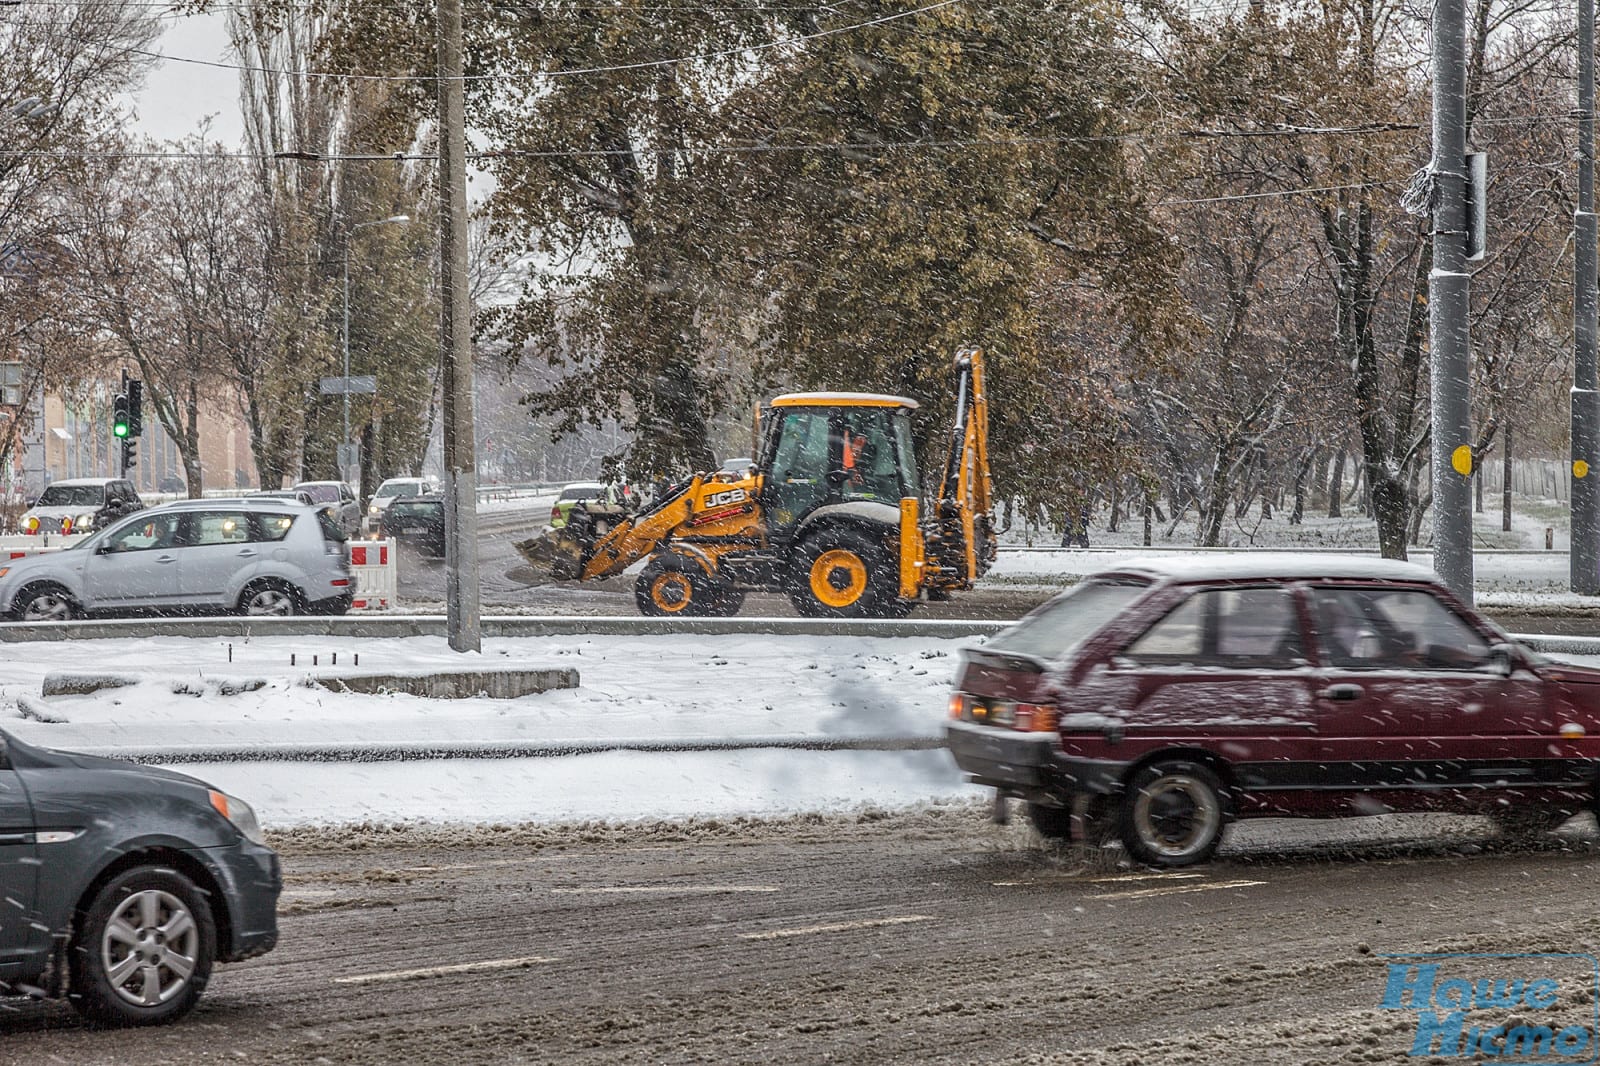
[{"left": 101, "top": 888, "right": 200, "bottom": 1007}]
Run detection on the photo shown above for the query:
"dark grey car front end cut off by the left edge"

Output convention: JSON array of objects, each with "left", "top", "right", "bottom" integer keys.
[{"left": 0, "top": 731, "right": 283, "bottom": 1026}]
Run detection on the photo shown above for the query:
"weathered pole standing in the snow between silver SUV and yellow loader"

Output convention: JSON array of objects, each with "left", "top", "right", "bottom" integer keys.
[{"left": 438, "top": 0, "right": 483, "bottom": 651}]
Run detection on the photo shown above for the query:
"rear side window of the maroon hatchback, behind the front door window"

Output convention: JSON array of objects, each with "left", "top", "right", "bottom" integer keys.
[{"left": 1120, "top": 587, "right": 1306, "bottom": 669}]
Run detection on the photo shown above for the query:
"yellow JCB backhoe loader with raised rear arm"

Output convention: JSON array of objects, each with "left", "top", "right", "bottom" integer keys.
[{"left": 517, "top": 351, "right": 995, "bottom": 618}]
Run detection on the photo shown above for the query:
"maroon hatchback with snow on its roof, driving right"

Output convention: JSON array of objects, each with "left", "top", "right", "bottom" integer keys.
[{"left": 947, "top": 554, "right": 1600, "bottom": 866}]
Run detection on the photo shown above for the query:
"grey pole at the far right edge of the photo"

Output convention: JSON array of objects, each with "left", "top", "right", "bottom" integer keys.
[{"left": 1568, "top": 0, "right": 1600, "bottom": 595}]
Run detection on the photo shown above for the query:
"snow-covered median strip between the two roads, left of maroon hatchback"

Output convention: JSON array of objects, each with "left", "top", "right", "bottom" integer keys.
[{"left": 0, "top": 635, "right": 976, "bottom": 826}]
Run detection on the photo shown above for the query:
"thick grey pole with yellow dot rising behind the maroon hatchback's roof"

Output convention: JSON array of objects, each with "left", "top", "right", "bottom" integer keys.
[{"left": 1429, "top": 0, "right": 1472, "bottom": 603}]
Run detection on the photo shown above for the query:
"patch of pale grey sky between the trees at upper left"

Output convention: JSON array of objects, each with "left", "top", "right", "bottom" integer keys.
[{"left": 133, "top": 14, "right": 245, "bottom": 146}]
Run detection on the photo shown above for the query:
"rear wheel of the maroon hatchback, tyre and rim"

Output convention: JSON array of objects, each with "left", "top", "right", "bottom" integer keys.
[{"left": 1120, "top": 759, "right": 1227, "bottom": 869}]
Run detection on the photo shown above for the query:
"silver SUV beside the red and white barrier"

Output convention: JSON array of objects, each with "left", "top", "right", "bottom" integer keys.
[{"left": 0, "top": 498, "right": 355, "bottom": 621}]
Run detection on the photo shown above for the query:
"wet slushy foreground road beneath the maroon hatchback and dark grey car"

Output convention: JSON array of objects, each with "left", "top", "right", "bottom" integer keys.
[{"left": 12, "top": 808, "right": 1600, "bottom": 1066}]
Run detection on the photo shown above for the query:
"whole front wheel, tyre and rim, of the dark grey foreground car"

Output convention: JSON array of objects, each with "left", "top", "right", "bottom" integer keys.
[{"left": 70, "top": 866, "right": 216, "bottom": 1026}]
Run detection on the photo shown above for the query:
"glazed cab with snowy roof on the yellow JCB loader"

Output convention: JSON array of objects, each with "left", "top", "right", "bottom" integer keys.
[{"left": 760, "top": 392, "right": 918, "bottom": 539}]
